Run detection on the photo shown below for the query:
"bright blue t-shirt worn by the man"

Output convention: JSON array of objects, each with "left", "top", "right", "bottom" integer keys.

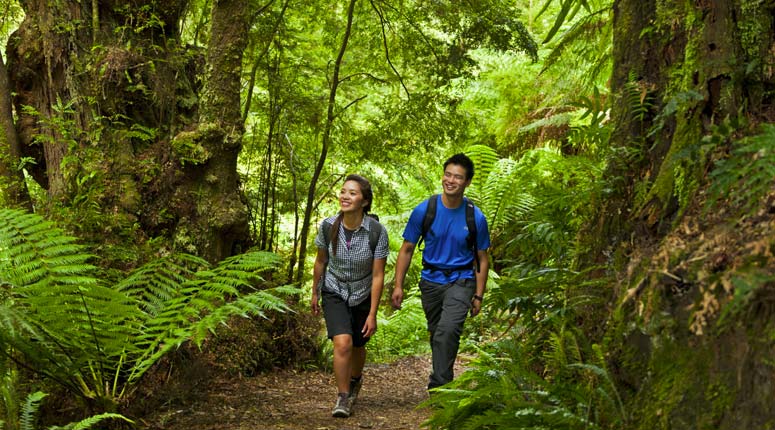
[{"left": 403, "top": 195, "right": 490, "bottom": 284}]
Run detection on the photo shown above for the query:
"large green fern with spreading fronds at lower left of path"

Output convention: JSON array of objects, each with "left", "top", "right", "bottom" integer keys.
[{"left": 0, "top": 209, "right": 298, "bottom": 412}]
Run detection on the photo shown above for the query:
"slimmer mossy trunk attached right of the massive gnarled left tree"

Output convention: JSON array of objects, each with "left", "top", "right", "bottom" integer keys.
[{"left": 173, "top": 0, "right": 251, "bottom": 261}]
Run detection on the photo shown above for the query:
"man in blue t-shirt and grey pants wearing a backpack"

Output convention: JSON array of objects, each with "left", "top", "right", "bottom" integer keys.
[{"left": 392, "top": 154, "right": 490, "bottom": 390}]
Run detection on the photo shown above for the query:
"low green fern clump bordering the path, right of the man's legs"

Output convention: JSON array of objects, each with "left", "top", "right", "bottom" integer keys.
[{"left": 425, "top": 269, "right": 626, "bottom": 430}]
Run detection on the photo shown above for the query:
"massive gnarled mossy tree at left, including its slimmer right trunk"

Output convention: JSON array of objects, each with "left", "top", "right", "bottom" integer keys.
[{"left": 7, "top": 0, "right": 251, "bottom": 264}]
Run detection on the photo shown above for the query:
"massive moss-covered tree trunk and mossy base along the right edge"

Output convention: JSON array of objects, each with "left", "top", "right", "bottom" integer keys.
[{"left": 586, "top": 0, "right": 775, "bottom": 429}]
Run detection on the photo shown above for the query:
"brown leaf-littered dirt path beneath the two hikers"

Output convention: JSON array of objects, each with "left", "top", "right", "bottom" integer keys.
[{"left": 145, "top": 356, "right": 442, "bottom": 430}]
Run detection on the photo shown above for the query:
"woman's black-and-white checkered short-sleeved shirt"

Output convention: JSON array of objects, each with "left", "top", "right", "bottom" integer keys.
[{"left": 315, "top": 216, "right": 389, "bottom": 306}]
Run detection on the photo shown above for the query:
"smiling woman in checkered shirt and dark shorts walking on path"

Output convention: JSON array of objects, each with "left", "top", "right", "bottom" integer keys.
[{"left": 311, "top": 175, "right": 388, "bottom": 418}]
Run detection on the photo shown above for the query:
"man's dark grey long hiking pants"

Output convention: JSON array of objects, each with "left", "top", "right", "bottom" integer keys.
[{"left": 420, "top": 279, "right": 476, "bottom": 390}]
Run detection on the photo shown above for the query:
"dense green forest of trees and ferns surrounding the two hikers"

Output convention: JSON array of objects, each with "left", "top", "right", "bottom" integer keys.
[{"left": 0, "top": 0, "right": 775, "bottom": 430}]
